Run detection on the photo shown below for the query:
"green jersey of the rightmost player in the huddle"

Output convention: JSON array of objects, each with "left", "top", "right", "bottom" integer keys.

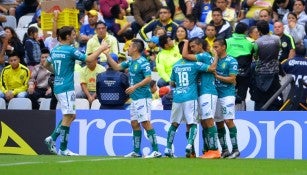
[{"left": 215, "top": 55, "right": 238, "bottom": 98}]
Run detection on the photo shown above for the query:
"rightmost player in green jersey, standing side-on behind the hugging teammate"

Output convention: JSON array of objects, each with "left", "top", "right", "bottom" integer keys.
[{"left": 213, "top": 39, "right": 240, "bottom": 159}]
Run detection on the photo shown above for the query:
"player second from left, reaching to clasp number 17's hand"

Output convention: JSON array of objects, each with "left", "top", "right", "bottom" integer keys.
[{"left": 106, "top": 39, "right": 162, "bottom": 158}]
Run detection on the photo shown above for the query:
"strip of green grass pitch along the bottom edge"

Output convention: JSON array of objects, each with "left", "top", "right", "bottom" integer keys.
[{"left": 0, "top": 155, "right": 307, "bottom": 175}]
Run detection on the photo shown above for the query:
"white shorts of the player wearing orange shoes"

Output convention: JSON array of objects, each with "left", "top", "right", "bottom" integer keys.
[{"left": 198, "top": 94, "right": 217, "bottom": 120}]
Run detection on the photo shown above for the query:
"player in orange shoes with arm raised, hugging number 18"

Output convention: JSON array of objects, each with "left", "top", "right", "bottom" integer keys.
[{"left": 182, "top": 38, "right": 221, "bottom": 159}]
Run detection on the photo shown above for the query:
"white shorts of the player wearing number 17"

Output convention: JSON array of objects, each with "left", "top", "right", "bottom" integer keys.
[{"left": 55, "top": 91, "right": 76, "bottom": 114}]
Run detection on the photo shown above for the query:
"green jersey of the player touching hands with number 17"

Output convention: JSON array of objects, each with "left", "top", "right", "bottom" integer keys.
[{"left": 121, "top": 56, "right": 152, "bottom": 100}]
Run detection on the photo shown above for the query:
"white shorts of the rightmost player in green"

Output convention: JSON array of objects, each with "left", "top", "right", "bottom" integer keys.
[{"left": 214, "top": 96, "right": 236, "bottom": 122}]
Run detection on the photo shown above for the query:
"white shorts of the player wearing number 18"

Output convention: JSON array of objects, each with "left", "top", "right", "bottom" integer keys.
[{"left": 171, "top": 100, "right": 198, "bottom": 125}]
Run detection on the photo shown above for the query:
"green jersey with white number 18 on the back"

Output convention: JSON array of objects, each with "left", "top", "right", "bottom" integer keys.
[{"left": 171, "top": 59, "right": 209, "bottom": 103}]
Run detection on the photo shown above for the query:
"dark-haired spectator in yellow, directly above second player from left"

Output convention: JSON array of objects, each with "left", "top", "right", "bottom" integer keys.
[{"left": 111, "top": 5, "right": 131, "bottom": 42}]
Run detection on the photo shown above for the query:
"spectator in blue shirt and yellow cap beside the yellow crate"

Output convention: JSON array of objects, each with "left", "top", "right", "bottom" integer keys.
[{"left": 79, "top": 10, "right": 98, "bottom": 53}]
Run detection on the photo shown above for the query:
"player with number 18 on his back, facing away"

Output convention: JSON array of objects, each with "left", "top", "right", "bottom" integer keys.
[{"left": 164, "top": 39, "right": 215, "bottom": 157}]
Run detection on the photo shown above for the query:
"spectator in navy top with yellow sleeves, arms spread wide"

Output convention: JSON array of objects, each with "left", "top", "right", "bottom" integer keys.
[{"left": 140, "top": 7, "right": 178, "bottom": 41}]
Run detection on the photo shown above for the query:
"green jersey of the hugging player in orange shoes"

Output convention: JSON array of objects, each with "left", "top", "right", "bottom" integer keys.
[{"left": 195, "top": 52, "right": 217, "bottom": 96}]
